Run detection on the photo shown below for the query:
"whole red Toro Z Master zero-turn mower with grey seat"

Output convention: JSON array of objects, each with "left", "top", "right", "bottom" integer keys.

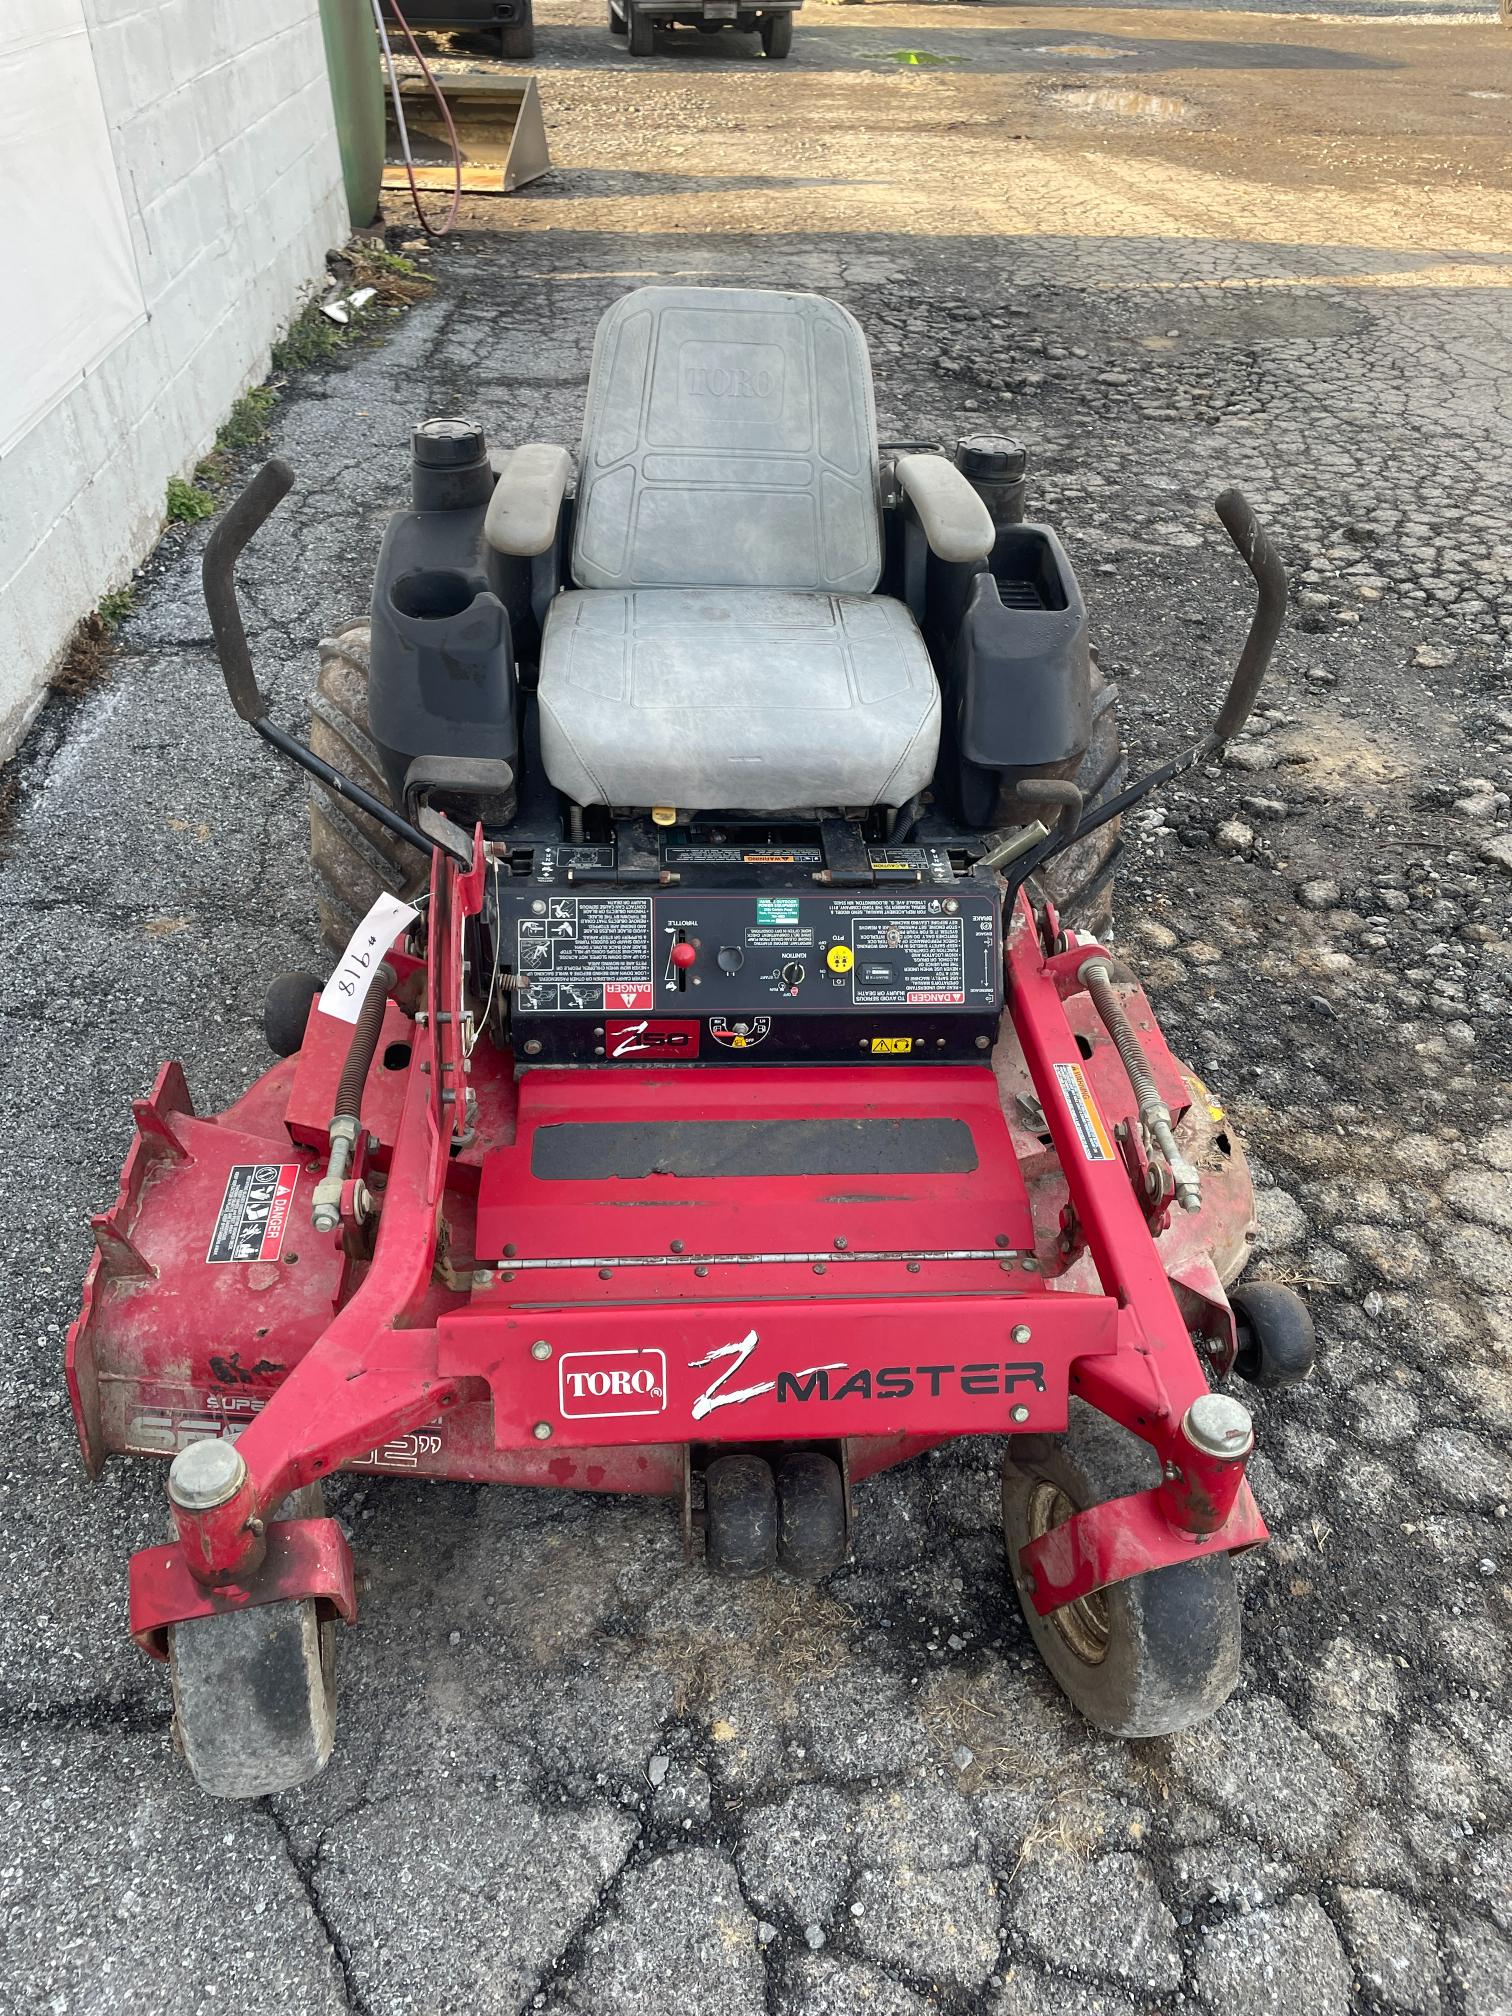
[{"left": 69, "top": 286, "right": 1312, "bottom": 1796}]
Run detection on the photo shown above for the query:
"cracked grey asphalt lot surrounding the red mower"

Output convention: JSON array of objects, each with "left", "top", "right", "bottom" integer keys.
[{"left": 0, "top": 0, "right": 1512, "bottom": 2016}]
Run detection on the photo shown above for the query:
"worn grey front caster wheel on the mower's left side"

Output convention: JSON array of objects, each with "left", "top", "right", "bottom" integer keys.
[{"left": 167, "top": 1597, "right": 337, "bottom": 1798}]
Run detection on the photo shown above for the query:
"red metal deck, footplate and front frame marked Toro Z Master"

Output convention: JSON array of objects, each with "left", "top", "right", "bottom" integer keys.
[{"left": 69, "top": 855, "right": 1266, "bottom": 1657}]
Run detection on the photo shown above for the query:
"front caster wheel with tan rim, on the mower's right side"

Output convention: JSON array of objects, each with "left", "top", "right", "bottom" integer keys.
[{"left": 1002, "top": 1399, "right": 1240, "bottom": 1738}]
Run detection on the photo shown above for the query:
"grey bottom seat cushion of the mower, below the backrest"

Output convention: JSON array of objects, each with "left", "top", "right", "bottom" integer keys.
[{"left": 540, "top": 589, "right": 939, "bottom": 812}]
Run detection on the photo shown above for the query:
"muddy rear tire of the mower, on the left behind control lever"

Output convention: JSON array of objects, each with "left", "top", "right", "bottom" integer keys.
[{"left": 310, "top": 617, "right": 425, "bottom": 952}]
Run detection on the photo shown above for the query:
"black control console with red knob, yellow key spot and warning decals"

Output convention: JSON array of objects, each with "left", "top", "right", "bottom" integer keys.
[{"left": 492, "top": 843, "right": 1002, "bottom": 1064}]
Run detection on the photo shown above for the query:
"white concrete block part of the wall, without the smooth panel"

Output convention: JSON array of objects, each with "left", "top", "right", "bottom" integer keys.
[{"left": 0, "top": 0, "right": 349, "bottom": 758}]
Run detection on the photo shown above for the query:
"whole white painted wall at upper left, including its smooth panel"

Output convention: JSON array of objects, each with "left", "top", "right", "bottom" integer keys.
[{"left": 0, "top": 0, "right": 349, "bottom": 758}]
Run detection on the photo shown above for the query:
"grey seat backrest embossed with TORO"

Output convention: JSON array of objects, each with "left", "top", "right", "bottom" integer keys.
[{"left": 573, "top": 286, "right": 883, "bottom": 595}]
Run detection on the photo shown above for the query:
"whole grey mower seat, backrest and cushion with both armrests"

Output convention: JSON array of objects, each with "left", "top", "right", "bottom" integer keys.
[{"left": 516, "top": 286, "right": 975, "bottom": 812}]
